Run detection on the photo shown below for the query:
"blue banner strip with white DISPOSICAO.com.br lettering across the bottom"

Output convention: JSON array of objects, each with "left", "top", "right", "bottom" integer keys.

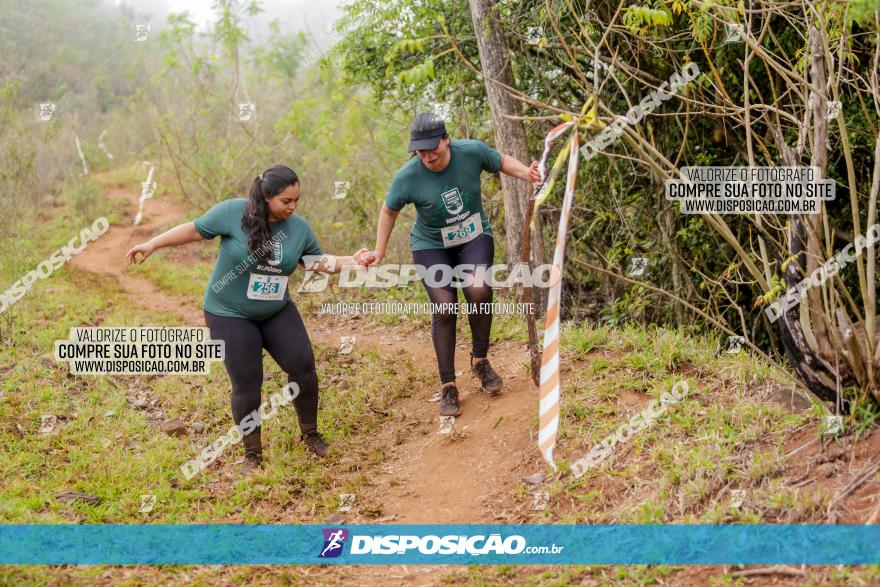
[{"left": 0, "top": 524, "right": 880, "bottom": 565}]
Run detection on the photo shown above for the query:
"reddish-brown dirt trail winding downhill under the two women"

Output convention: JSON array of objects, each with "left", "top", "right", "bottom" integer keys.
[{"left": 73, "top": 173, "right": 542, "bottom": 523}]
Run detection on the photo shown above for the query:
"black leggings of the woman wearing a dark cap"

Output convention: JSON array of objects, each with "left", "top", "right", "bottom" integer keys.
[{"left": 413, "top": 234, "right": 495, "bottom": 383}]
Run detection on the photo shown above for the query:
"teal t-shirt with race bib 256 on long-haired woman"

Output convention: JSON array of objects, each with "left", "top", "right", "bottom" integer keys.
[{"left": 194, "top": 198, "right": 321, "bottom": 320}]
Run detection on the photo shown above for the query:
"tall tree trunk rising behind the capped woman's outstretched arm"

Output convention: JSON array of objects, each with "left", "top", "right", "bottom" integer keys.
[{"left": 469, "top": 0, "right": 539, "bottom": 265}]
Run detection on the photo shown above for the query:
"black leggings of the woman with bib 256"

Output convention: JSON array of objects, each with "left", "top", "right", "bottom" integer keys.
[{"left": 205, "top": 302, "right": 318, "bottom": 434}]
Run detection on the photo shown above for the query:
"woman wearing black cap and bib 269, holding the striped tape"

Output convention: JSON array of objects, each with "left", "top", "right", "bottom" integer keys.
[{"left": 356, "top": 113, "right": 540, "bottom": 416}]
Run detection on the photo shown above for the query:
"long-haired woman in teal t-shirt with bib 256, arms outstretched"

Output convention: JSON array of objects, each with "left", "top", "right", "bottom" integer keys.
[{"left": 128, "top": 165, "right": 366, "bottom": 472}]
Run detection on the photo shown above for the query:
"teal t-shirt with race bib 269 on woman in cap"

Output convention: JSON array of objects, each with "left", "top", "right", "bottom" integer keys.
[{"left": 385, "top": 139, "right": 501, "bottom": 251}]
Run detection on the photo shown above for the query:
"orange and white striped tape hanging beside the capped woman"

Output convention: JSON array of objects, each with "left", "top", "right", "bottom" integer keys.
[{"left": 538, "top": 122, "right": 578, "bottom": 470}]
